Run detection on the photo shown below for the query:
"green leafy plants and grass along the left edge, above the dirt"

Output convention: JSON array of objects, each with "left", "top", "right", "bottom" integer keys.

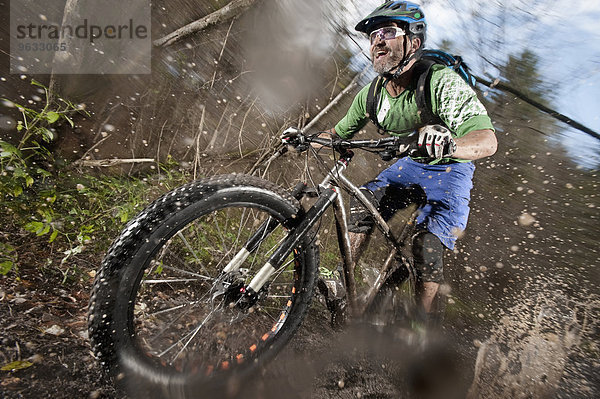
[{"left": 0, "top": 81, "right": 190, "bottom": 281}]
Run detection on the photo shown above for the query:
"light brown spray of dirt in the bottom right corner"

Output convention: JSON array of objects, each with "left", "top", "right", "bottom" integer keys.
[{"left": 467, "top": 287, "right": 600, "bottom": 399}]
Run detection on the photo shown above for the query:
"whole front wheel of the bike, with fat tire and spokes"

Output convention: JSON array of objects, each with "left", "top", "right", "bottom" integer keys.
[{"left": 88, "top": 175, "right": 318, "bottom": 392}]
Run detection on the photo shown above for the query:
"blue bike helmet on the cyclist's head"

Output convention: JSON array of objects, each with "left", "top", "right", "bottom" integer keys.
[{"left": 354, "top": 0, "right": 427, "bottom": 42}]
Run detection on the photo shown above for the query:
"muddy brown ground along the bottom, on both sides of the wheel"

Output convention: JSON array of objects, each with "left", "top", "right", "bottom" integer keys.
[{"left": 0, "top": 239, "right": 600, "bottom": 399}]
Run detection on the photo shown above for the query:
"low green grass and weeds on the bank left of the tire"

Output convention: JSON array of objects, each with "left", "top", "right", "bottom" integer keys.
[{"left": 0, "top": 164, "right": 188, "bottom": 283}]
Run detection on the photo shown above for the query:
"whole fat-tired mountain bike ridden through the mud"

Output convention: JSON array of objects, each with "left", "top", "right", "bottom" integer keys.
[{"left": 88, "top": 129, "right": 432, "bottom": 393}]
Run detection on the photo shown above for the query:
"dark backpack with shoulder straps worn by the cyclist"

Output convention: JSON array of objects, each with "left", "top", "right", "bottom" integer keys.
[{"left": 367, "top": 49, "right": 476, "bottom": 134}]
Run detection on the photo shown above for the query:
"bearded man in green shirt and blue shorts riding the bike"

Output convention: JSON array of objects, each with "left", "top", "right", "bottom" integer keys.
[{"left": 323, "top": 1, "right": 497, "bottom": 313}]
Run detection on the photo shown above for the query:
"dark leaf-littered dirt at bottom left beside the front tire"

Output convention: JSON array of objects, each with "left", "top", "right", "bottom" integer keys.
[{"left": 0, "top": 268, "right": 115, "bottom": 399}]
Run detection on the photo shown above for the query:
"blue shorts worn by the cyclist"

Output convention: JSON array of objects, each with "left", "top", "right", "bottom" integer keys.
[{"left": 363, "top": 157, "right": 475, "bottom": 249}]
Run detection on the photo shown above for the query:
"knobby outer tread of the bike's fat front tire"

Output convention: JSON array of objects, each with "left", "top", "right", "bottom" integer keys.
[{"left": 88, "top": 174, "right": 318, "bottom": 390}]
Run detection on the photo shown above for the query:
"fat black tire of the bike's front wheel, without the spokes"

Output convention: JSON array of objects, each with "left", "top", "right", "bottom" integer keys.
[{"left": 88, "top": 175, "right": 319, "bottom": 396}]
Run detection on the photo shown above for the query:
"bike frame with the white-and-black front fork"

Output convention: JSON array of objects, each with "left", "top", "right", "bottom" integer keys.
[{"left": 224, "top": 142, "right": 417, "bottom": 316}]
